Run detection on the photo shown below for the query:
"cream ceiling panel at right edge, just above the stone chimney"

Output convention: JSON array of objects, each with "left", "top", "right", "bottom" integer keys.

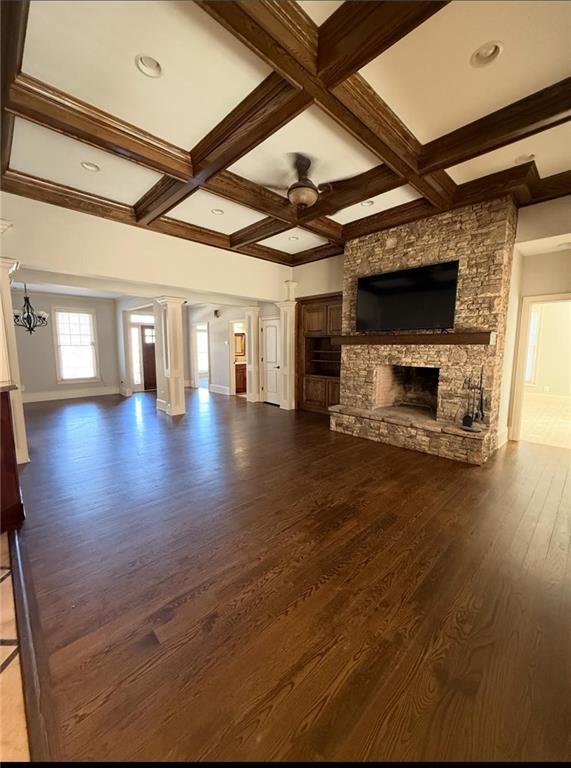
[{"left": 447, "top": 123, "right": 571, "bottom": 184}]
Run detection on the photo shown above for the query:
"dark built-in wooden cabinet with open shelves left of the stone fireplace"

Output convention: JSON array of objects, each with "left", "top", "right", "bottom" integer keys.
[{"left": 297, "top": 293, "right": 342, "bottom": 413}]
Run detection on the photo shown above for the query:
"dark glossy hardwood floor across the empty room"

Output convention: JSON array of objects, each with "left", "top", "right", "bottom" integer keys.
[{"left": 15, "top": 390, "right": 571, "bottom": 760}]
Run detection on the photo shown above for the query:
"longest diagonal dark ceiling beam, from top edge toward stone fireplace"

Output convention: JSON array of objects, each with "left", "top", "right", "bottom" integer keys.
[{"left": 198, "top": 0, "right": 454, "bottom": 207}]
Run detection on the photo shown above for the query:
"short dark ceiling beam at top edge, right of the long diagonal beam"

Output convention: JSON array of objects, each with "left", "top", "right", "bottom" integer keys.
[{"left": 317, "top": 0, "right": 447, "bottom": 87}]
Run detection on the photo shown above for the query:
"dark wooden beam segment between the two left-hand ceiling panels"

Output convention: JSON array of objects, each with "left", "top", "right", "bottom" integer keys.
[{"left": 7, "top": 74, "right": 192, "bottom": 179}]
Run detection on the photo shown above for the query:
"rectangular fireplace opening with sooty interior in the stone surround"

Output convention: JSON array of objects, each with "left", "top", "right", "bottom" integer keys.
[{"left": 375, "top": 365, "right": 440, "bottom": 419}]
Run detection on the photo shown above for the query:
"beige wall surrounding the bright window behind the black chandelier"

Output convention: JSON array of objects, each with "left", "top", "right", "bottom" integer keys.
[{"left": 12, "top": 290, "right": 120, "bottom": 401}]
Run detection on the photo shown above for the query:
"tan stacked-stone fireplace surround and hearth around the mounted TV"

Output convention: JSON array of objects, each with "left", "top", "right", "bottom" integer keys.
[{"left": 331, "top": 197, "right": 517, "bottom": 464}]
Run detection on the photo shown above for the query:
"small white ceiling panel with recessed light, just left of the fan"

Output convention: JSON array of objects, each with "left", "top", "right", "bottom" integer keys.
[{"left": 167, "top": 189, "right": 266, "bottom": 235}]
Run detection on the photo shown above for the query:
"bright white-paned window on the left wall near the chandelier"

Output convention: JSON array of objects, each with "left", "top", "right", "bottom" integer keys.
[{"left": 55, "top": 309, "right": 98, "bottom": 381}]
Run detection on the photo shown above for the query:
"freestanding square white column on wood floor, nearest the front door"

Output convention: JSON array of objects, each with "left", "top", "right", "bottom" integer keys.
[{"left": 154, "top": 296, "right": 186, "bottom": 416}]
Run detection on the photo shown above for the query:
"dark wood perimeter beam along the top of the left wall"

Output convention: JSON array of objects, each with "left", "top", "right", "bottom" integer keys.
[{"left": 2, "top": 169, "right": 291, "bottom": 266}]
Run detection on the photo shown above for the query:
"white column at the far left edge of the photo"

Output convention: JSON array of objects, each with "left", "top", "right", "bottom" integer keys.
[{"left": 0, "top": 257, "right": 30, "bottom": 464}]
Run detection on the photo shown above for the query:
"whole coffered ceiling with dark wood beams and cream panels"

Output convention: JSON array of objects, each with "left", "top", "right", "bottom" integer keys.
[{"left": 0, "top": 0, "right": 571, "bottom": 265}]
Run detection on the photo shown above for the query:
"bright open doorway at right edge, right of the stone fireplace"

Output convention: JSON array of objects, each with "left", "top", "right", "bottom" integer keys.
[{"left": 514, "top": 294, "right": 571, "bottom": 449}]
